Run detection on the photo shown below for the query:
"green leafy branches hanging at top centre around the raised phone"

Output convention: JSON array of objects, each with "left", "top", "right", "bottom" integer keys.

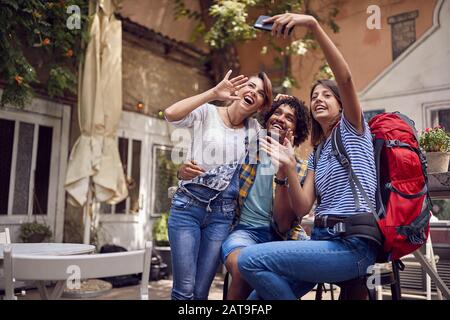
[{"left": 173, "top": 0, "right": 339, "bottom": 89}]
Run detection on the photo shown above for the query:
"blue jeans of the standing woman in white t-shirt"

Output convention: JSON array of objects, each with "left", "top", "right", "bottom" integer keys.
[{"left": 169, "top": 174, "right": 239, "bottom": 300}]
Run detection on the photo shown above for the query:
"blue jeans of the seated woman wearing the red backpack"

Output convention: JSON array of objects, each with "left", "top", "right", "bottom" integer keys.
[{"left": 238, "top": 228, "right": 378, "bottom": 300}]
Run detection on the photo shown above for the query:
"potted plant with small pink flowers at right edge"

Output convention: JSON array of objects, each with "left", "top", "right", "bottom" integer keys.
[{"left": 419, "top": 126, "right": 450, "bottom": 173}]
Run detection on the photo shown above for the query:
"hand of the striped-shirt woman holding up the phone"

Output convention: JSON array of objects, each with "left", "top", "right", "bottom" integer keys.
[{"left": 264, "top": 13, "right": 317, "bottom": 38}]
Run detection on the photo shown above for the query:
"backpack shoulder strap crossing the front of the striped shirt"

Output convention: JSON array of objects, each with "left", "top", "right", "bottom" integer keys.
[{"left": 331, "top": 124, "right": 380, "bottom": 222}]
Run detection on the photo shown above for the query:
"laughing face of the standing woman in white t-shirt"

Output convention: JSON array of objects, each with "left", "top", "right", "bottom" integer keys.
[{"left": 237, "top": 77, "right": 267, "bottom": 114}]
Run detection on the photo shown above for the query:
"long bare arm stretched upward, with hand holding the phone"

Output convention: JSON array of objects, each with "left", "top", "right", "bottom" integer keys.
[{"left": 265, "top": 13, "right": 363, "bottom": 133}]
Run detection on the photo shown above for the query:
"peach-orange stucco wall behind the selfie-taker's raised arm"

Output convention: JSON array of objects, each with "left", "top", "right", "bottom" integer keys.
[{"left": 291, "top": 0, "right": 436, "bottom": 99}]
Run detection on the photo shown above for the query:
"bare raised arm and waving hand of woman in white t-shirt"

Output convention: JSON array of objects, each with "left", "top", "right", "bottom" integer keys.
[{"left": 164, "top": 70, "right": 248, "bottom": 122}]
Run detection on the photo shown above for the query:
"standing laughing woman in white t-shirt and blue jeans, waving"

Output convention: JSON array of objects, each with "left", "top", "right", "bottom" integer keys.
[{"left": 165, "top": 70, "right": 272, "bottom": 300}]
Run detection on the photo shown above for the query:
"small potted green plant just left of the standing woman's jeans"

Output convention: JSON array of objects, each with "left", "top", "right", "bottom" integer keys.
[{"left": 152, "top": 212, "right": 172, "bottom": 275}]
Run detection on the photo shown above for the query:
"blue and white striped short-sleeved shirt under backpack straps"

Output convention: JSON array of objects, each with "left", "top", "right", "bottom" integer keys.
[{"left": 308, "top": 115, "right": 377, "bottom": 215}]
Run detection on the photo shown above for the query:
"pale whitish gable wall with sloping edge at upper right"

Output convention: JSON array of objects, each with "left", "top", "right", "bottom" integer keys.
[{"left": 361, "top": 1, "right": 450, "bottom": 130}]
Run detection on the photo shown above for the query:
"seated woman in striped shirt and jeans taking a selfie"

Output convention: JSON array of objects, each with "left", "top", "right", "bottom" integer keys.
[{"left": 238, "top": 13, "right": 378, "bottom": 300}]
